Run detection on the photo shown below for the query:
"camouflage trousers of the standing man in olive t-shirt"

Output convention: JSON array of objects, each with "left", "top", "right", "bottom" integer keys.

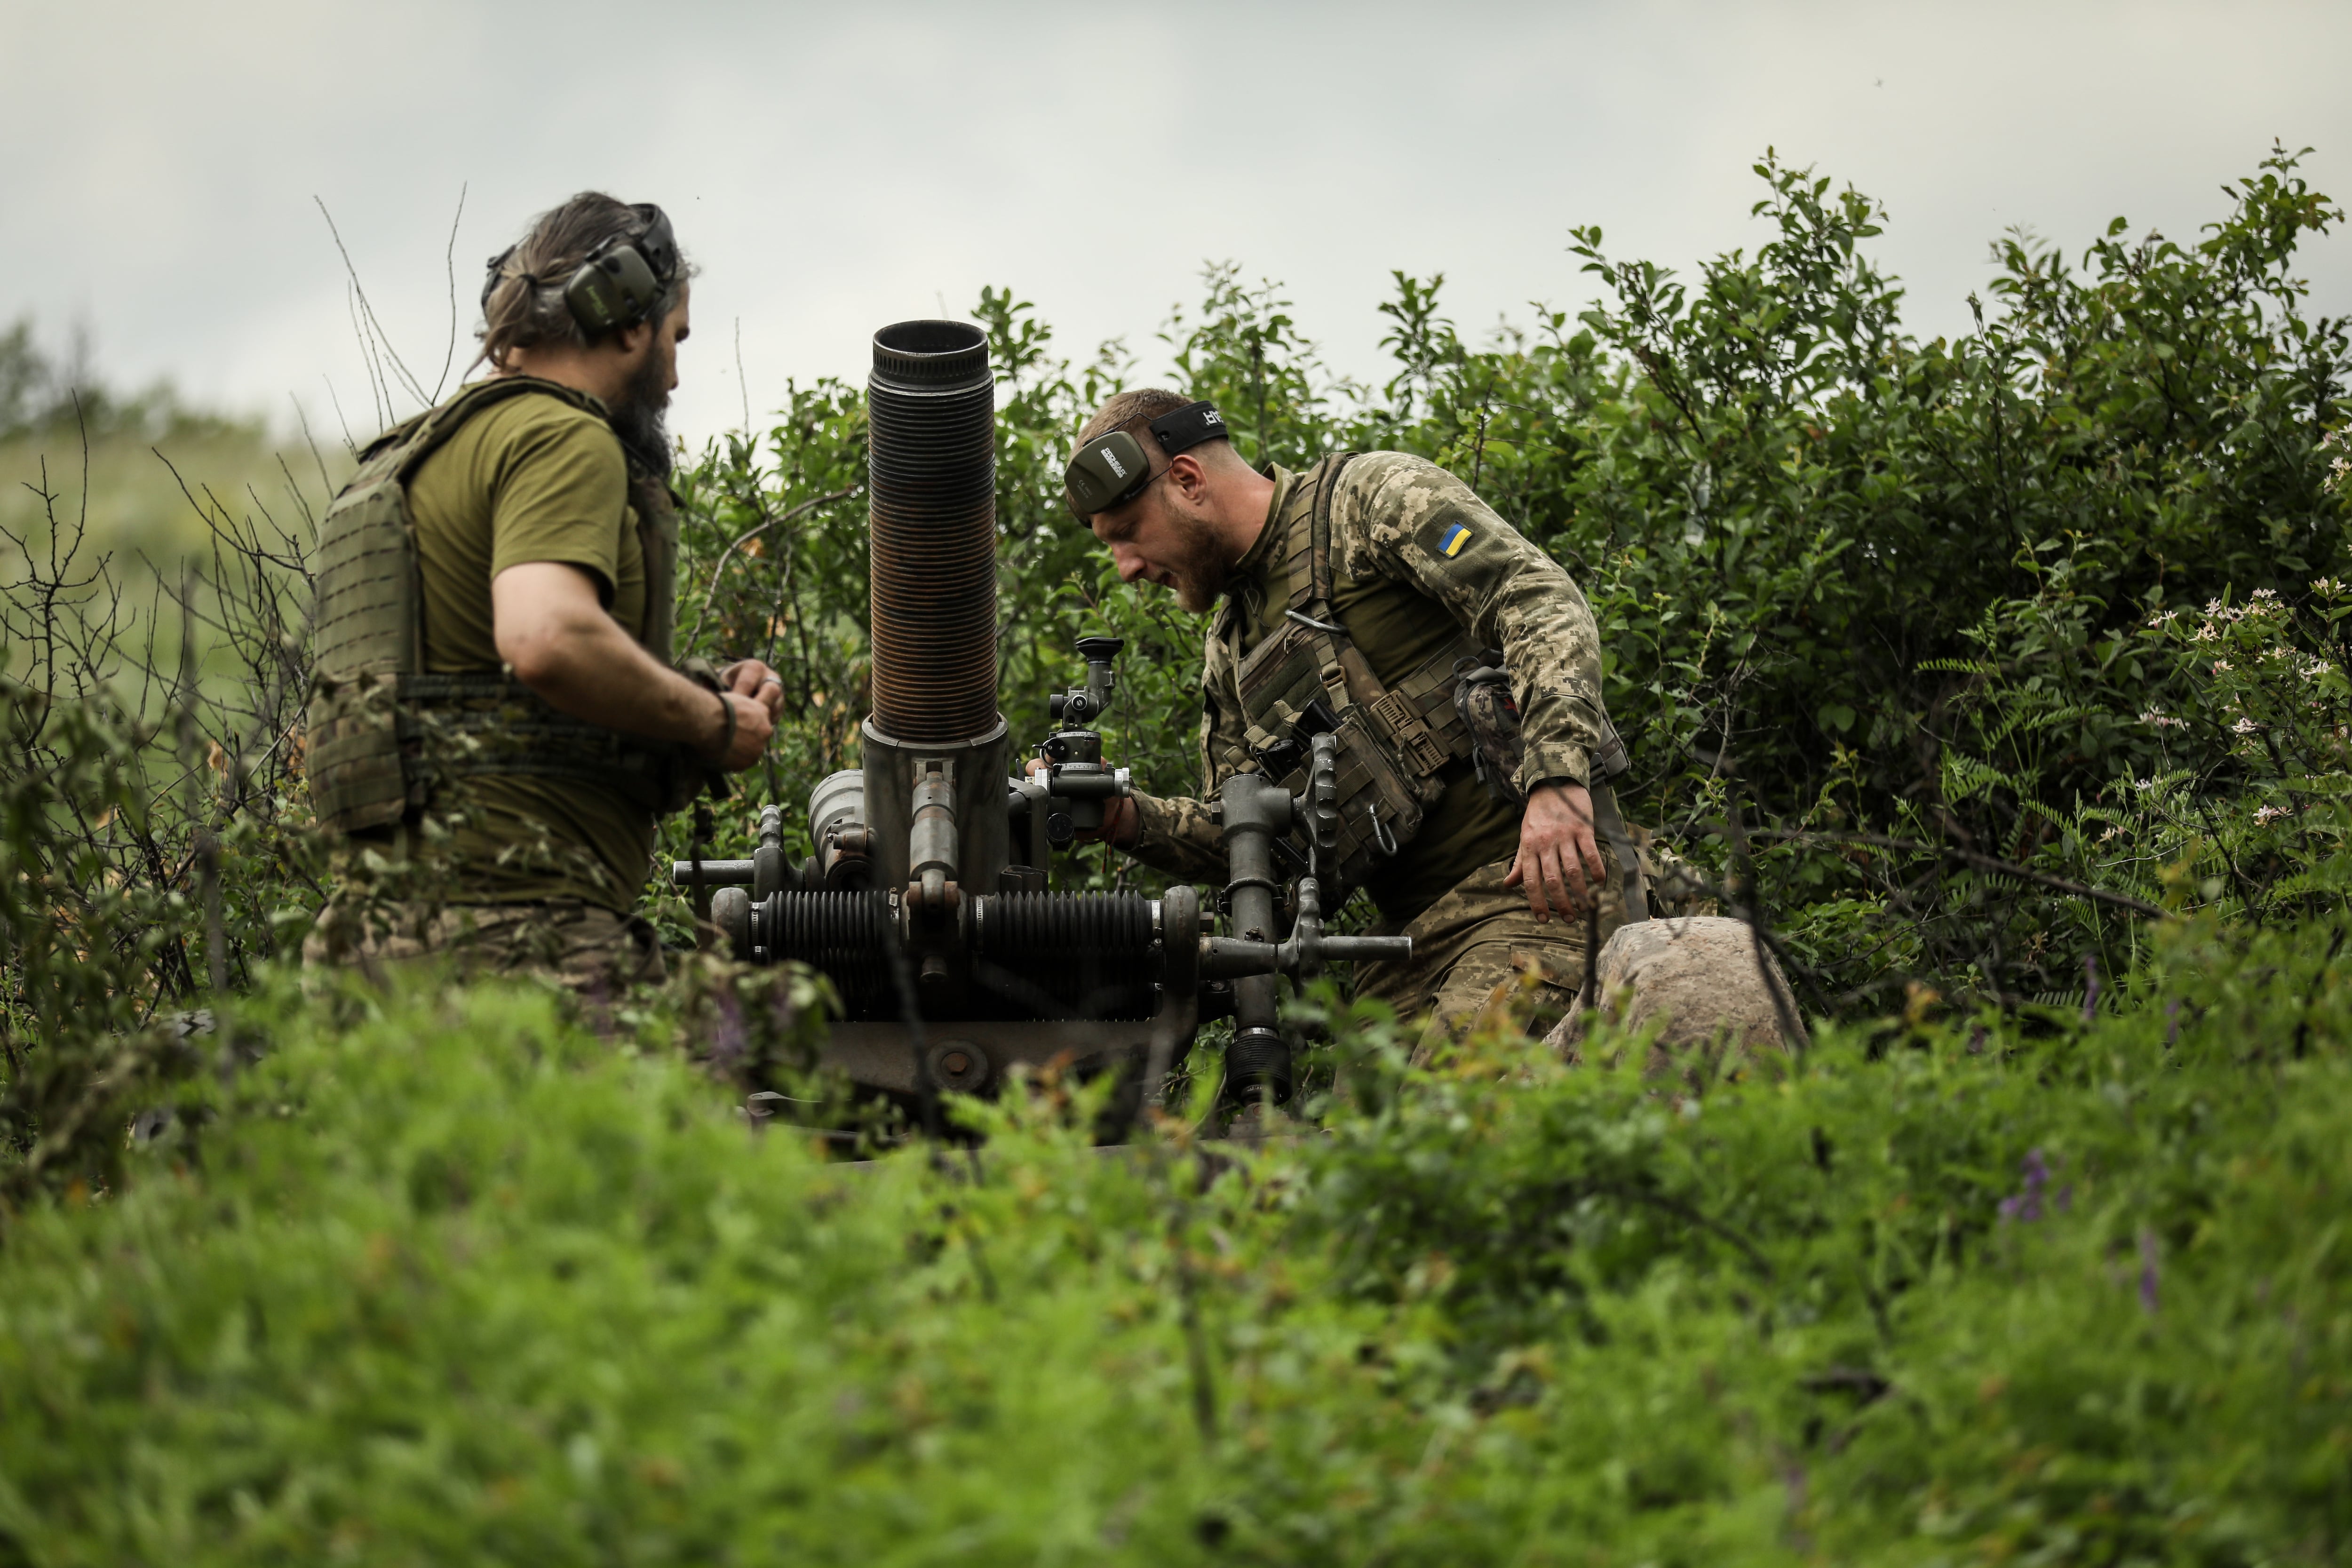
[{"left": 301, "top": 896, "right": 668, "bottom": 997}]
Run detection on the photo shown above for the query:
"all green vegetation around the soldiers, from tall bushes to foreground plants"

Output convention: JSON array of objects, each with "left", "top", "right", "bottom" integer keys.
[{"left": 0, "top": 153, "right": 2352, "bottom": 1566}]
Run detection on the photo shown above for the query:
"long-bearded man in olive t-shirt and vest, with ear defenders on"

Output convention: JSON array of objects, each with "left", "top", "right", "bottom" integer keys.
[{"left": 303, "top": 193, "right": 783, "bottom": 987}]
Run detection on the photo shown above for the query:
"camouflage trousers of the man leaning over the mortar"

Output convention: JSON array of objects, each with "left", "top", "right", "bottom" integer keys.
[{"left": 1355, "top": 853, "right": 1625, "bottom": 1063}]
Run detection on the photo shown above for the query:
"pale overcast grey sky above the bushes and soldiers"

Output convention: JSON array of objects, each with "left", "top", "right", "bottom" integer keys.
[{"left": 0, "top": 0, "right": 2352, "bottom": 439}]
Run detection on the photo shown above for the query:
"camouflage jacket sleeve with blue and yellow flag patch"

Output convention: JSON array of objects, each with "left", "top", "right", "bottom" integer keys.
[{"left": 1331, "top": 451, "right": 1602, "bottom": 790}]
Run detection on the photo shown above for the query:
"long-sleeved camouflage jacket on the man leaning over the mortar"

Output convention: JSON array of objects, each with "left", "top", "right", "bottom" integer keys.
[{"left": 1131, "top": 451, "right": 1602, "bottom": 882}]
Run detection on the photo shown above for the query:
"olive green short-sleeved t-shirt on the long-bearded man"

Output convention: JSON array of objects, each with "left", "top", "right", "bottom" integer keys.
[{"left": 395, "top": 392, "right": 666, "bottom": 912}]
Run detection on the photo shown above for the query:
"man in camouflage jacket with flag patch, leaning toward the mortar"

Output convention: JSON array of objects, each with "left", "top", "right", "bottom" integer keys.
[{"left": 1068, "top": 390, "right": 1644, "bottom": 1042}]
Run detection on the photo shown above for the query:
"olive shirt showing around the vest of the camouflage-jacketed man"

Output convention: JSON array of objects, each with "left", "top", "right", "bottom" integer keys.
[{"left": 1235, "top": 475, "right": 1522, "bottom": 926}]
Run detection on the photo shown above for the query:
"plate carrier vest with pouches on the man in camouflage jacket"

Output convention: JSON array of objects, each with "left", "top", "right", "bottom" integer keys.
[{"left": 1225, "top": 451, "right": 1646, "bottom": 919}]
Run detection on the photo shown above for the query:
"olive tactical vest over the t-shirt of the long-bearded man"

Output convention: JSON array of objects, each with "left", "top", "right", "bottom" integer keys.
[{"left": 306, "top": 376, "right": 724, "bottom": 832}]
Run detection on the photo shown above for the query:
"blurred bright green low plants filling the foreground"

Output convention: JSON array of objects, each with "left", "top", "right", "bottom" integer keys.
[{"left": 0, "top": 926, "right": 2352, "bottom": 1563}]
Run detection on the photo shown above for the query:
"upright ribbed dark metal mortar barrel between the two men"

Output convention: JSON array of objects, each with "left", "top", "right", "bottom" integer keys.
[{"left": 866, "top": 322, "right": 997, "bottom": 745}]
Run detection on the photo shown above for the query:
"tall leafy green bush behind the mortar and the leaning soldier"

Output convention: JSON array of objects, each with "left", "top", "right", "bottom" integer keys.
[{"left": 659, "top": 151, "right": 2352, "bottom": 1016}]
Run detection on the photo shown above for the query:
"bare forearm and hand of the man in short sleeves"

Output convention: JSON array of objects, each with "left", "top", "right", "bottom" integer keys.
[{"left": 489, "top": 562, "right": 781, "bottom": 771}]
